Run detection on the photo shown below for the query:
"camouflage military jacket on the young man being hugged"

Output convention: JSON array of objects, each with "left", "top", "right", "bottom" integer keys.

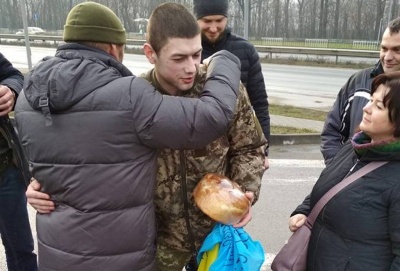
[{"left": 142, "top": 67, "right": 267, "bottom": 255}]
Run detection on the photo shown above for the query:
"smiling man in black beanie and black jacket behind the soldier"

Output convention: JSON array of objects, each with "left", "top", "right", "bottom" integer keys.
[{"left": 193, "top": 0, "right": 270, "bottom": 168}]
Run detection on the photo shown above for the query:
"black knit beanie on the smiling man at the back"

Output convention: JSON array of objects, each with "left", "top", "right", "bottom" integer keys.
[{"left": 193, "top": 0, "right": 228, "bottom": 19}]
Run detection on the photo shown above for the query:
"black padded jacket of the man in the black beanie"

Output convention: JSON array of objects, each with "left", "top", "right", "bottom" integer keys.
[{"left": 201, "top": 28, "right": 270, "bottom": 154}]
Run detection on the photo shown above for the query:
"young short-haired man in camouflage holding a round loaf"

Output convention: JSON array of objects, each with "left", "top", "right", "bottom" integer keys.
[{"left": 23, "top": 3, "right": 267, "bottom": 271}]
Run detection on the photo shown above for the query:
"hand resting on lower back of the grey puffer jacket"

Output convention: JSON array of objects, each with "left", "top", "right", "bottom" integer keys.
[{"left": 25, "top": 178, "right": 55, "bottom": 214}]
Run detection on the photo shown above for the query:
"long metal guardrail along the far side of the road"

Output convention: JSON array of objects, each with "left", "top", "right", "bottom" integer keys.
[{"left": 0, "top": 34, "right": 379, "bottom": 63}]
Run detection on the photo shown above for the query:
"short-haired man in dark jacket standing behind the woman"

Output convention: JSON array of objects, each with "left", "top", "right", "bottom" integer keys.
[{"left": 321, "top": 18, "right": 400, "bottom": 163}]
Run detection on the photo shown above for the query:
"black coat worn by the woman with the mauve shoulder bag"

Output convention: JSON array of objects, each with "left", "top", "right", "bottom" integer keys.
[{"left": 292, "top": 139, "right": 400, "bottom": 271}]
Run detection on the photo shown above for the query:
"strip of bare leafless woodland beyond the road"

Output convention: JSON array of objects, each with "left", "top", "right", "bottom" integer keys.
[{"left": 0, "top": 0, "right": 400, "bottom": 40}]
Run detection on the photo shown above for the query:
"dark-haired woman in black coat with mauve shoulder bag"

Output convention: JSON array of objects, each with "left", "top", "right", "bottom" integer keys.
[{"left": 289, "top": 72, "right": 400, "bottom": 271}]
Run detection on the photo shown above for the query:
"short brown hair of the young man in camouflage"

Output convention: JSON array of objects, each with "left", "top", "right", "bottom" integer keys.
[{"left": 146, "top": 3, "right": 200, "bottom": 54}]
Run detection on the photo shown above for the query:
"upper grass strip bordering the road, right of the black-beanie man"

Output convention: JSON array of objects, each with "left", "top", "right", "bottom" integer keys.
[{"left": 269, "top": 104, "right": 328, "bottom": 121}]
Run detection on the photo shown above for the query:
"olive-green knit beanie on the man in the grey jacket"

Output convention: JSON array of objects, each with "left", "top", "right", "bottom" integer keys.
[{"left": 64, "top": 2, "right": 126, "bottom": 44}]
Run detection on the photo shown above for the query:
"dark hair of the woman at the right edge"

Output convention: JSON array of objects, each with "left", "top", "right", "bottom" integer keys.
[{"left": 371, "top": 71, "right": 400, "bottom": 137}]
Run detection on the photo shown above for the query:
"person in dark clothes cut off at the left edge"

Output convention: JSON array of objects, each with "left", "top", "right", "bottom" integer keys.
[{"left": 0, "top": 53, "right": 37, "bottom": 271}]
